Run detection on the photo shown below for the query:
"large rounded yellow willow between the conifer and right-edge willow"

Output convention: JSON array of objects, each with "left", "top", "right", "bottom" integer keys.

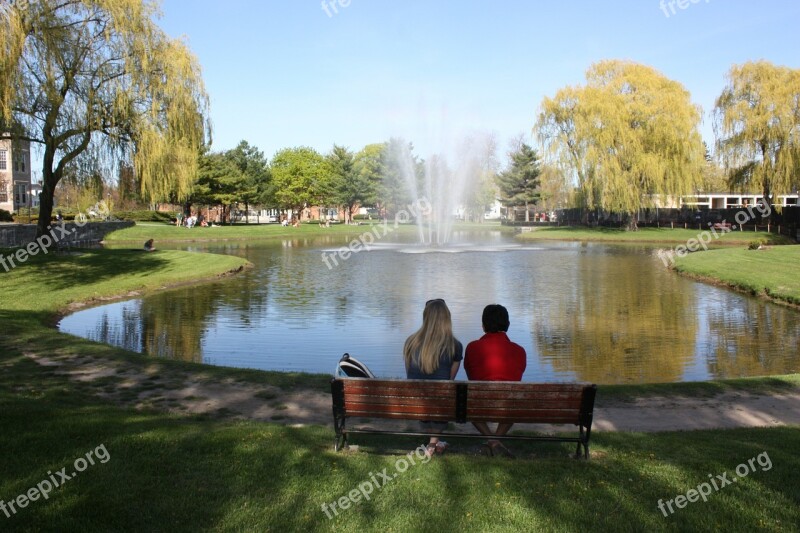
[{"left": 535, "top": 61, "right": 704, "bottom": 229}]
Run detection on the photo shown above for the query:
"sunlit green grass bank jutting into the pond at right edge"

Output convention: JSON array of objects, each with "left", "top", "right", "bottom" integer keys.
[{"left": 675, "top": 245, "right": 800, "bottom": 305}]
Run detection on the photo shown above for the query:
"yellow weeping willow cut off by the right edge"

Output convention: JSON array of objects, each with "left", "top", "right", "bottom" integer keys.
[{"left": 714, "top": 61, "right": 800, "bottom": 211}]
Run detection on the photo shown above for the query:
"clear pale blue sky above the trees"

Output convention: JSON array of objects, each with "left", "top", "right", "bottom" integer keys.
[{"left": 159, "top": 0, "right": 800, "bottom": 162}]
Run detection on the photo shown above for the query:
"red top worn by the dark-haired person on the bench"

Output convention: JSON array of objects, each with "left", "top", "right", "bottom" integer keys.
[{"left": 464, "top": 331, "right": 527, "bottom": 381}]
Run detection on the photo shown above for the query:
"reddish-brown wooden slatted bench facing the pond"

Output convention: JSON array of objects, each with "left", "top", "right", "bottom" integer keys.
[{"left": 331, "top": 378, "right": 597, "bottom": 459}]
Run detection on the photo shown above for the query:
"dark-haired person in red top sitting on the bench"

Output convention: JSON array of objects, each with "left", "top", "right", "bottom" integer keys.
[{"left": 464, "top": 304, "right": 527, "bottom": 457}]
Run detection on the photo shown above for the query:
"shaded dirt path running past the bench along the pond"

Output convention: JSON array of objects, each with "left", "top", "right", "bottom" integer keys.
[{"left": 27, "top": 354, "right": 800, "bottom": 432}]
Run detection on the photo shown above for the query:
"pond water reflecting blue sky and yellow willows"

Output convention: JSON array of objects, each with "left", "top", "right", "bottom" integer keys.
[{"left": 59, "top": 232, "right": 800, "bottom": 384}]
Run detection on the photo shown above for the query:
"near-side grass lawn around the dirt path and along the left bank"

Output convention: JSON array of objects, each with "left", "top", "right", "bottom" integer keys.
[{"left": 0, "top": 244, "right": 800, "bottom": 531}]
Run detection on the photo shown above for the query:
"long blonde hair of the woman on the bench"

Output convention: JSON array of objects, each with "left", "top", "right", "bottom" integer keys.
[{"left": 403, "top": 300, "right": 456, "bottom": 374}]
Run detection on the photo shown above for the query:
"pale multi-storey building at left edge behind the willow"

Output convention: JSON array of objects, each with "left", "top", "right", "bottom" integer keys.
[{"left": 0, "top": 135, "right": 31, "bottom": 213}]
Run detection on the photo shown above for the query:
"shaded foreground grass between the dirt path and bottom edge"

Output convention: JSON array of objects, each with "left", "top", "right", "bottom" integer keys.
[{"left": 0, "top": 368, "right": 800, "bottom": 531}]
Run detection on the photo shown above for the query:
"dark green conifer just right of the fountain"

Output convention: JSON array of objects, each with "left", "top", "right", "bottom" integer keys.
[{"left": 497, "top": 142, "right": 541, "bottom": 222}]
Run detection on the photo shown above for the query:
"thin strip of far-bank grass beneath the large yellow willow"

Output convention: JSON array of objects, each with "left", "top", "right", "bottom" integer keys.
[{"left": 517, "top": 227, "right": 792, "bottom": 247}]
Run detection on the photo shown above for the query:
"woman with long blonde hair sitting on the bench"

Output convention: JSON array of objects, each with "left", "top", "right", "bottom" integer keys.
[{"left": 403, "top": 299, "right": 464, "bottom": 456}]
